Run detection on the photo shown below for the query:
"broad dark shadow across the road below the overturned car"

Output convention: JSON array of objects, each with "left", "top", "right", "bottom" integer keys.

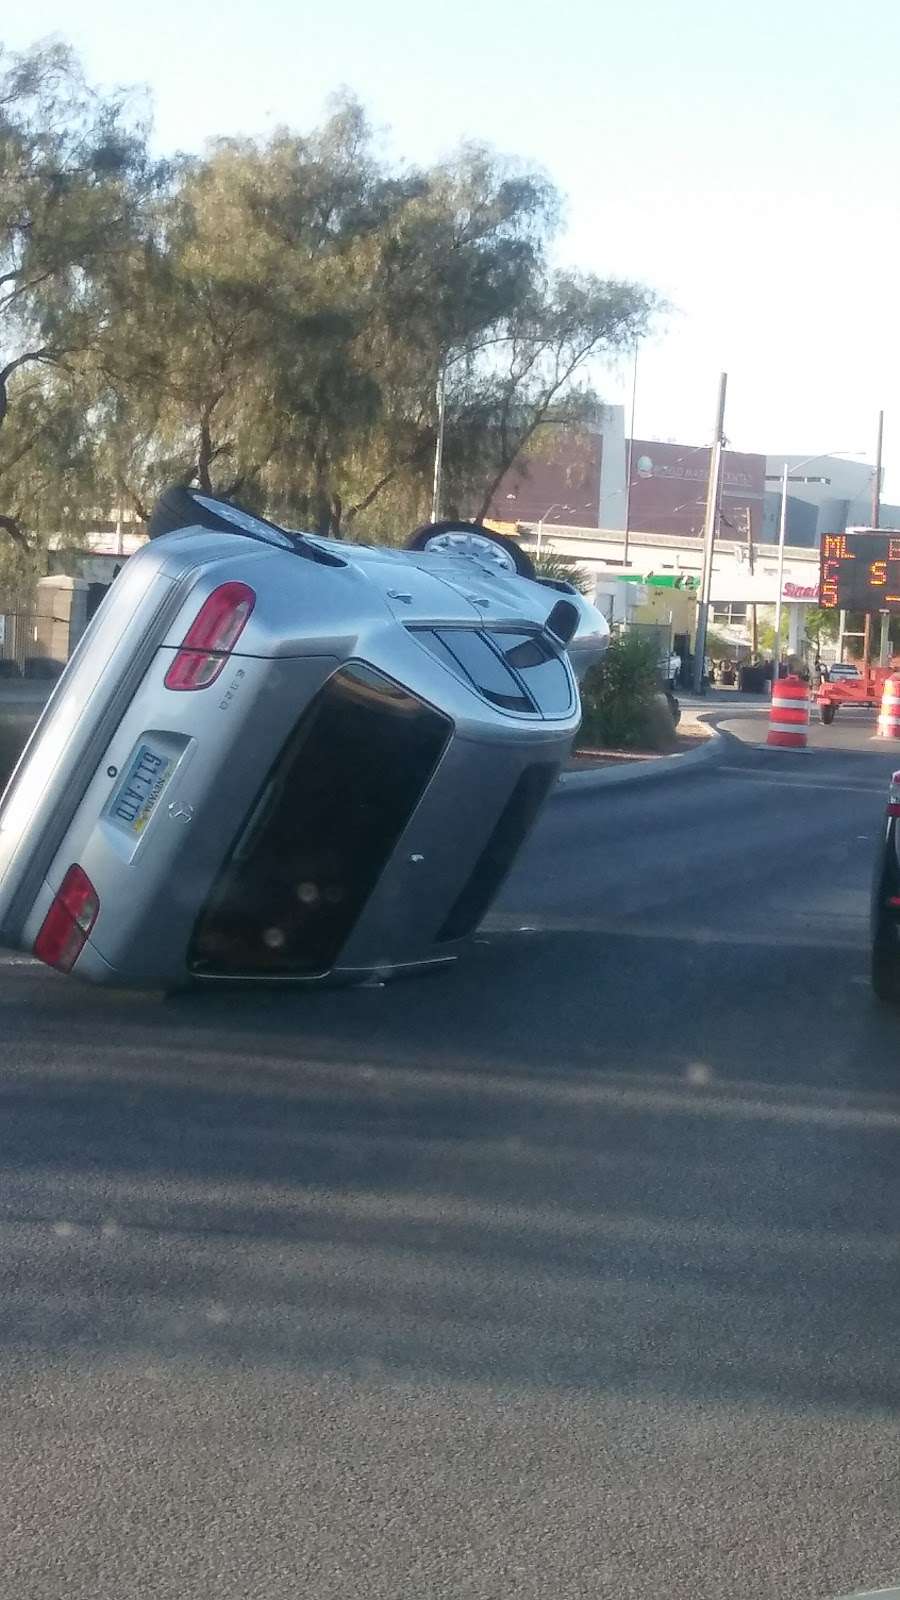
[{"left": 0, "top": 930, "right": 900, "bottom": 1411}]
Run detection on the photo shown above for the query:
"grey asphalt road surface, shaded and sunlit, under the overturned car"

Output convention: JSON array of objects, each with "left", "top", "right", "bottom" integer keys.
[{"left": 0, "top": 710, "right": 900, "bottom": 1600}]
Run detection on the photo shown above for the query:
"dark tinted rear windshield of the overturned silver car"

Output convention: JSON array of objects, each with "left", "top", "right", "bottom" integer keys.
[{"left": 189, "top": 662, "right": 452, "bottom": 976}]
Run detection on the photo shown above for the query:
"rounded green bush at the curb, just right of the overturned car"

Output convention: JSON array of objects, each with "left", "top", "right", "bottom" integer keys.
[{"left": 581, "top": 634, "right": 674, "bottom": 750}]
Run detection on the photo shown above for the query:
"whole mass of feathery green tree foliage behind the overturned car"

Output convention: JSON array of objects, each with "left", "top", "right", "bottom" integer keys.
[{"left": 0, "top": 45, "right": 655, "bottom": 556}]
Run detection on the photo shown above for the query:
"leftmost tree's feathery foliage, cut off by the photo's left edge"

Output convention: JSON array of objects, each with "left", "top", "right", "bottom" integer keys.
[{"left": 0, "top": 43, "right": 162, "bottom": 547}]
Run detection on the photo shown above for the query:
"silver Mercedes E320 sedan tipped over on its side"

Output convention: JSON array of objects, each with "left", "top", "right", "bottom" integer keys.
[{"left": 0, "top": 490, "right": 609, "bottom": 989}]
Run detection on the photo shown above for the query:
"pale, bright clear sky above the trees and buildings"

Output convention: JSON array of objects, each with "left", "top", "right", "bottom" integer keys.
[{"left": 7, "top": 0, "right": 900, "bottom": 499}]
